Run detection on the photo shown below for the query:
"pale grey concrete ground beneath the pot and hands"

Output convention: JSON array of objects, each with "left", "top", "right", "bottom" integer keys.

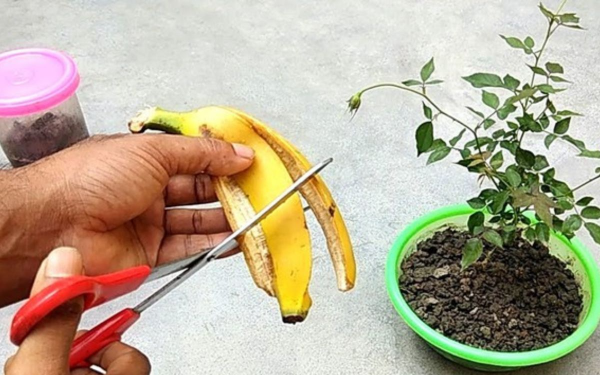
[{"left": 0, "top": 0, "right": 600, "bottom": 375}]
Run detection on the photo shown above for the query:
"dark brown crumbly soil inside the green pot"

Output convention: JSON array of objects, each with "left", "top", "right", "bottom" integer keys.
[{"left": 399, "top": 229, "right": 583, "bottom": 352}]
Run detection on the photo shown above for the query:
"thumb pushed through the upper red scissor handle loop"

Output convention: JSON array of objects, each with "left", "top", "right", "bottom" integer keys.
[{"left": 12, "top": 247, "right": 83, "bottom": 374}]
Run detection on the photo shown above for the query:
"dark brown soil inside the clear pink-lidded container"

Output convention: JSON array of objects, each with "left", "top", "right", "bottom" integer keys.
[{"left": 2, "top": 112, "right": 88, "bottom": 167}]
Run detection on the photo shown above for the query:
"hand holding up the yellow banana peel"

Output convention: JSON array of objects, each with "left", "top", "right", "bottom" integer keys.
[{"left": 0, "top": 134, "right": 254, "bottom": 304}]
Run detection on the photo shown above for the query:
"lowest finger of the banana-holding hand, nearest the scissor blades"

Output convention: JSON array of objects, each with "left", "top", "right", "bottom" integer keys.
[{"left": 157, "top": 233, "right": 239, "bottom": 265}]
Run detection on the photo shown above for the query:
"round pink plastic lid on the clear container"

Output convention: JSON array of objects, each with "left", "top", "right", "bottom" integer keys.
[{"left": 0, "top": 48, "right": 79, "bottom": 117}]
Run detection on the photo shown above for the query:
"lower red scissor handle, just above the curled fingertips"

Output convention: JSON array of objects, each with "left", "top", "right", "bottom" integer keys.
[{"left": 69, "top": 309, "right": 140, "bottom": 369}]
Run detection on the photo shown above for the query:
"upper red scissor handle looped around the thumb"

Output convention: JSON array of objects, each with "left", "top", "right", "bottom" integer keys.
[{"left": 10, "top": 266, "right": 151, "bottom": 345}]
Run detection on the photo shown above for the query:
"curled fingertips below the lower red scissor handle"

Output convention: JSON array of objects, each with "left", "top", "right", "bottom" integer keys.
[{"left": 71, "top": 341, "right": 151, "bottom": 375}]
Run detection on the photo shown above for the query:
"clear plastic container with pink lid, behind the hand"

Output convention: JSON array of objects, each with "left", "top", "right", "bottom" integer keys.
[{"left": 0, "top": 49, "right": 89, "bottom": 167}]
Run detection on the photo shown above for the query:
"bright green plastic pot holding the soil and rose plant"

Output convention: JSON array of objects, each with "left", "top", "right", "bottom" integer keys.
[{"left": 385, "top": 205, "right": 600, "bottom": 372}]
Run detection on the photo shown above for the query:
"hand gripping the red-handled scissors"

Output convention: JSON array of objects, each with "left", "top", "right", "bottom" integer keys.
[{"left": 4, "top": 247, "right": 150, "bottom": 375}]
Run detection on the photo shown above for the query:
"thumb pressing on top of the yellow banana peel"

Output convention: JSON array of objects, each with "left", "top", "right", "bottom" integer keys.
[{"left": 136, "top": 134, "right": 254, "bottom": 176}]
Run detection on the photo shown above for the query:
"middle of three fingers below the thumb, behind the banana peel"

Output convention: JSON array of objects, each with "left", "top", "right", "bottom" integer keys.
[{"left": 165, "top": 208, "right": 231, "bottom": 234}]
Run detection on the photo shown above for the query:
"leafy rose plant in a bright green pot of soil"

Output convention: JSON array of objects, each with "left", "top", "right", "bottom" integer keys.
[{"left": 348, "top": 1, "right": 600, "bottom": 371}]
